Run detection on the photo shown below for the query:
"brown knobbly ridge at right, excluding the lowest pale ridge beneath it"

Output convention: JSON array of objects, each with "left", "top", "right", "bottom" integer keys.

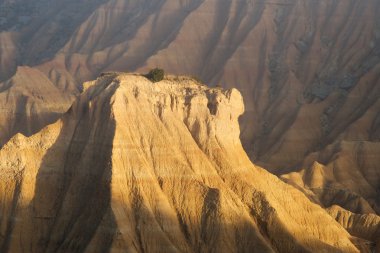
[{"left": 282, "top": 142, "right": 380, "bottom": 213}]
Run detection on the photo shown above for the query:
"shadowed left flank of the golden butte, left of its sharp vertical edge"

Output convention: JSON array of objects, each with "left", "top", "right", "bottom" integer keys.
[{"left": 1, "top": 74, "right": 117, "bottom": 252}]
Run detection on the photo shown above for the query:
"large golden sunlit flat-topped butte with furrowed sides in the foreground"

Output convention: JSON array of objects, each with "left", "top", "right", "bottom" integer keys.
[{"left": 0, "top": 74, "right": 358, "bottom": 253}]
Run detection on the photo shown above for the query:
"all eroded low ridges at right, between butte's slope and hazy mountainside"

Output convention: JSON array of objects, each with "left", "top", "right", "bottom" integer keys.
[{"left": 281, "top": 141, "right": 380, "bottom": 249}]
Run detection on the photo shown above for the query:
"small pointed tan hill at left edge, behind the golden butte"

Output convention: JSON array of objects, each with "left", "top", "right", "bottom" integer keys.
[{"left": 0, "top": 67, "right": 73, "bottom": 147}]
